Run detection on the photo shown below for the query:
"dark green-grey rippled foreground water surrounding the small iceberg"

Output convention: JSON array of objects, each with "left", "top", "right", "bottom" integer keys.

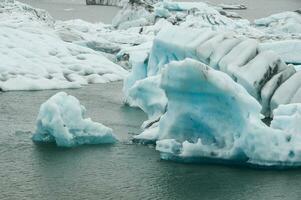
[{"left": 0, "top": 82, "right": 301, "bottom": 200}]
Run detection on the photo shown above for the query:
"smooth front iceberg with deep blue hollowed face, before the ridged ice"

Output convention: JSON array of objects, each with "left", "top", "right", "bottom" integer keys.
[{"left": 144, "top": 59, "right": 301, "bottom": 166}]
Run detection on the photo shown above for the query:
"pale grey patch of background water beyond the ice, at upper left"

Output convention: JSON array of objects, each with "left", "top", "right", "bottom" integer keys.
[{"left": 18, "top": 0, "right": 119, "bottom": 24}]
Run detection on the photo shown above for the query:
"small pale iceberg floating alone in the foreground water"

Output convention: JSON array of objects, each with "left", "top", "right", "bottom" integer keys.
[{"left": 32, "top": 92, "right": 117, "bottom": 147}]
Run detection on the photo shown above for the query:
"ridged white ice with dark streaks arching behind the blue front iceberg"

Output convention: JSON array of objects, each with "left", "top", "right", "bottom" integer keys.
[{"left": 124, "top": 26, "right": 301, "bottom": 116}]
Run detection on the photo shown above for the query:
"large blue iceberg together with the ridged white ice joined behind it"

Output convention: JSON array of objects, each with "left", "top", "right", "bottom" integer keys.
[{"left": 119, "top": 16, "right": 301, "bottom": 167}]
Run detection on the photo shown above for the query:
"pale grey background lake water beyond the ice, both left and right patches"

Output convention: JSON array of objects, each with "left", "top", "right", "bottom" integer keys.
[{"left": 19, "top": 0, "right": 301, "bottom": 23}]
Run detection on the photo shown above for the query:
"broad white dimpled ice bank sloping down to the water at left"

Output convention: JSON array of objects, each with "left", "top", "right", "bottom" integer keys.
[{"left": 0, "top": 0, "right": 127, "bottom": 91}]
